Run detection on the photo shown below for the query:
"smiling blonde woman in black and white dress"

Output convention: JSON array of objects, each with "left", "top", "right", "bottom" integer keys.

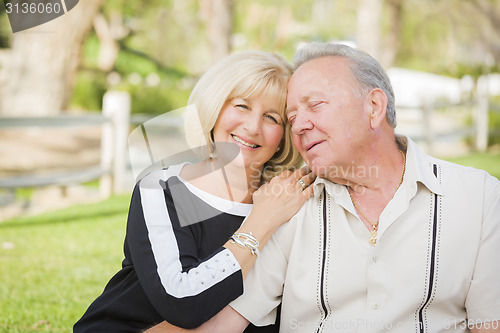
[{"left": 74, "top": 51, "right": 314, "bottom": 332}]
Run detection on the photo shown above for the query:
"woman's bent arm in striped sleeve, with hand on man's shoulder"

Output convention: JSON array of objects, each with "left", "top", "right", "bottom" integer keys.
[{"left": 126, "top": 169, "right": 314, "bottom": 328}]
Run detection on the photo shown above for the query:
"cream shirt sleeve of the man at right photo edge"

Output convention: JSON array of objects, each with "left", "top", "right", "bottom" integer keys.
[{"left": 465, "top": 175, "right": 500, "bottom": 324}]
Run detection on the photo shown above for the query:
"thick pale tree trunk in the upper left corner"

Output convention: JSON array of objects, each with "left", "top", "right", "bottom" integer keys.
[{"left": 0, "top": 0, "right": 104, "bottom": 116}]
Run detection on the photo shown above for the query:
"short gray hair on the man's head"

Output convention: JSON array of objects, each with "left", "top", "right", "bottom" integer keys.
[{"left": 293, "top": 42, "right": 396, "bottom": 128}]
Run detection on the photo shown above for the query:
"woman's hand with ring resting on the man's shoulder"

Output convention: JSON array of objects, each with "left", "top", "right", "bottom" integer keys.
[{"left": 252, "top": 167, "right": 316, "bottom": 228}]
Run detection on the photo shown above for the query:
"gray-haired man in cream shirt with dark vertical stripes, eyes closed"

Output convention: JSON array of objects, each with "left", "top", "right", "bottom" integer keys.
[{"left": 146, "top": 43, "right": 500, "bottom": 332}]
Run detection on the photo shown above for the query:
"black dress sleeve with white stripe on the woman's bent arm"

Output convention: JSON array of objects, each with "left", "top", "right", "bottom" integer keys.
[{"left": 126, "top": 179, "right": 243, "bottom": 328}]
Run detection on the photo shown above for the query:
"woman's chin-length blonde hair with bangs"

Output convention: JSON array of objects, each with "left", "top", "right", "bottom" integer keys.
[{"left": 185, "top": 51, "right": 302, "bottom": 181}]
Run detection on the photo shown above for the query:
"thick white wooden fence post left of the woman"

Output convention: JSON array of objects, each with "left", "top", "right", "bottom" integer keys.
[{"left": 100, "top": 91, "right": 131, "bottom": 196}]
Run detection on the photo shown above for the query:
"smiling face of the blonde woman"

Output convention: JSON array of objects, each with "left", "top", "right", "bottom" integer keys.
[{"left": 213, "top": 92, "right": 284, "bottom": 171}]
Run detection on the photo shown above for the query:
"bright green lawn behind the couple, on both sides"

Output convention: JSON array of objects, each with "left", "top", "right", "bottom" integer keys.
[{"left": 0, "top": 153, "right": 500, "bottom": 333}]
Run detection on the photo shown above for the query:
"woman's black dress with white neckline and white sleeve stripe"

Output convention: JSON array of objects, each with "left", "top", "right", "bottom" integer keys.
[{"left": 74, "top": 164, "right": 280, "bottom": 332}]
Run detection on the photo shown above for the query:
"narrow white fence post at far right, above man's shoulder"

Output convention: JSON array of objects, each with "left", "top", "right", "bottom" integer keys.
[{"left": 475, "top": 76, "right": 489, "bottom": 152}]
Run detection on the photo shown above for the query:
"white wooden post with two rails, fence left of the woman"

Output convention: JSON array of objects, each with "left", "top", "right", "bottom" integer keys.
[{"left": 0, "top": 91, "right": 130, "bottom": 198}]
